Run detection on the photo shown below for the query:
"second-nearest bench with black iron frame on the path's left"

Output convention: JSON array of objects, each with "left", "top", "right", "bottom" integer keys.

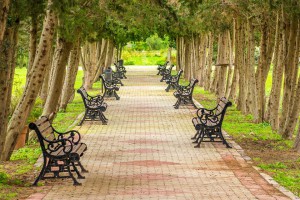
[{"left": 77, "top": 87, "right": 107, "bottom": 126}]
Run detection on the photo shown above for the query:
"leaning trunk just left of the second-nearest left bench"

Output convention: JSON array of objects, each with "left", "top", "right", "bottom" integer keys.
[{"left": 59, "top": 39, "right": 80, "bottom": 111}]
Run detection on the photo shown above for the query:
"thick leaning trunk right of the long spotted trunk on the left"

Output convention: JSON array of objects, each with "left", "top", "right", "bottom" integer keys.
[{"left": 42, "top": 37, "right": 73, "bottom": 120}]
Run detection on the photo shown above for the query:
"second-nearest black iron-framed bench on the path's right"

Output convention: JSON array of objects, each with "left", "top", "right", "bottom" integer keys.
[{"left": 174, "top": 78, "right": 198, "bottom": 109}]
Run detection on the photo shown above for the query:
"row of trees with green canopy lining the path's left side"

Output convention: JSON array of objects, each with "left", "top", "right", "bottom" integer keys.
[{"left": 0, "top": 0, "right": 171, "bottom": 160}]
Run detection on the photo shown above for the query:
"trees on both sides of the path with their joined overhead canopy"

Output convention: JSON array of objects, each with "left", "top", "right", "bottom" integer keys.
[{"left": 0, "top": 0, "right": 300, "bottom": 160}]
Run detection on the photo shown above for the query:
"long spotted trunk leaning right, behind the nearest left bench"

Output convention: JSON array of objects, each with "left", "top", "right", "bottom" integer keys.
[{"left": 1, "top": 0, "right": 56, "bottom": 160}]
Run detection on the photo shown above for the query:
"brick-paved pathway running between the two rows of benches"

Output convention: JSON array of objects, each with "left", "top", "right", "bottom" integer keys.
[{"left": 30, "top": 67, "right": 296, "bottom": 200}]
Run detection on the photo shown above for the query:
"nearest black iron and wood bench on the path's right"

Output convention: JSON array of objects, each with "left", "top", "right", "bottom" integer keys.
[{"left": 192, "top": 97, "right": 232, "bottom": 148}]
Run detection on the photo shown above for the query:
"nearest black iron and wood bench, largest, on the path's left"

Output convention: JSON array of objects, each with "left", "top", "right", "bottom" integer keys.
[{"left": 29, "top": 116, "right": 88, "bottom": 186}]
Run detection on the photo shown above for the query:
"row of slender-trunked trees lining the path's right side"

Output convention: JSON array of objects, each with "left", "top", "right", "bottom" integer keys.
[{"left": 177, "top": 0, "right": 300, "bottom": 151}]
